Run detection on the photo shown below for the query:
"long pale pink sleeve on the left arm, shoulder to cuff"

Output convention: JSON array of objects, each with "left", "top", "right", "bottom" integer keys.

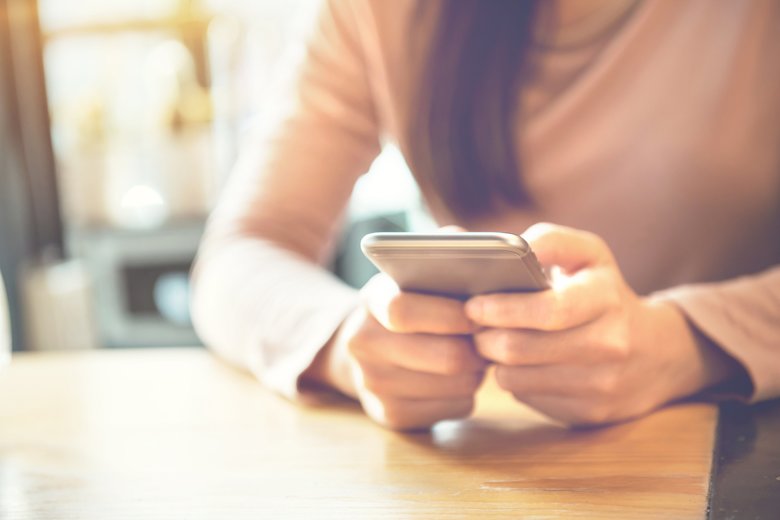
[{"left": 192, "top": 0, "right": 380, "bottom": 399}]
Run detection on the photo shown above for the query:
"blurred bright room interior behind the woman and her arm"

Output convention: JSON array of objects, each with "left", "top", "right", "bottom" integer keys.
[{"left": 0, "top": 0, "right": 431, "bottom": 350}]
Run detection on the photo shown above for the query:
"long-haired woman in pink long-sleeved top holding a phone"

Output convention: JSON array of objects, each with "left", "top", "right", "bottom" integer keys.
[{"left": 194, "top": 0, "right": 780, "bottom": 429}]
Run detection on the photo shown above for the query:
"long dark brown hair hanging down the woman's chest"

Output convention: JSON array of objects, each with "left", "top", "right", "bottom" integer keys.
[{"left": 409, "top": 0, "right": 537, "bottom": 218}]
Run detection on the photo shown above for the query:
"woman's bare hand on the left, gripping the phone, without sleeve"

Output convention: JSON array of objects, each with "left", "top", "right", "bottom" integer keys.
[{"left": 316, "top": 273, "right": 487, "bottom": 430}]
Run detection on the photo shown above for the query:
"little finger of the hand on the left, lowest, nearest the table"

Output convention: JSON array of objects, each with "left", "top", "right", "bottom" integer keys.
[{"left": 360, "top": 392, "right": 474, "bottom": 431}]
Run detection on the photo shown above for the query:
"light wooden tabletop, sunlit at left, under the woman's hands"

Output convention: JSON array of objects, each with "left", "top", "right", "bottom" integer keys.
[{"left": 0, "top": 349, "right": 717, "bottom": 520}]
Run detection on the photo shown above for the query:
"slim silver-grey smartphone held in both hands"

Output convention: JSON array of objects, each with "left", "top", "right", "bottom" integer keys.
[{"left": 360, "top": 233, "right": 549, "bottom": 299}]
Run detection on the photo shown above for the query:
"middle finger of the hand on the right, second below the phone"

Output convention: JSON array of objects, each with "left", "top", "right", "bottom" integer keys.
[{"left": 474, "top": 320, "right": 629, "bottom": 366}]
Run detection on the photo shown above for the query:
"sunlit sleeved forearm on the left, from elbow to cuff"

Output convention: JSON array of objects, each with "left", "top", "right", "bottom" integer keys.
[{"left": 193, "top": 236, "right": 356, "bottom": 398}]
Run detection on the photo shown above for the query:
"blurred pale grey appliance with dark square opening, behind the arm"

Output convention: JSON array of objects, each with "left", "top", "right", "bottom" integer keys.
[{"left": 69, "top": 220, "right": 204, "bottom": 347}]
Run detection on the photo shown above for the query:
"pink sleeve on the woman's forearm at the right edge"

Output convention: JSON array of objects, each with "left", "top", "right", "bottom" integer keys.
[{"left": 654, "top": 266, "right": 780, "bottom": 402}]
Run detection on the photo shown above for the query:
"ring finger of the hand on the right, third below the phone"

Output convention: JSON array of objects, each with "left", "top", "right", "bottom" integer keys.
[{"left": 495, "top": 365, "right": 617, "bottom": 400}]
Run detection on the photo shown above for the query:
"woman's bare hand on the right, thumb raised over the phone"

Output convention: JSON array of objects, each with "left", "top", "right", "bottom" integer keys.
[{"left": 466, "top": 224, "right": 732, "bottom": 424}]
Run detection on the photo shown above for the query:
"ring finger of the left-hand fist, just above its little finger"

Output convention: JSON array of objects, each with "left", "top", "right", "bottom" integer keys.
[{"left": 361, "top": 365, "right": 484, "bottom": 400}]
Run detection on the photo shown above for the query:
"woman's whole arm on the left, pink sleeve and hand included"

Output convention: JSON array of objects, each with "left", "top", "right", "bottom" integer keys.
[{"left": 193, "top": 0, "right": 485, "bottom": 429}]
